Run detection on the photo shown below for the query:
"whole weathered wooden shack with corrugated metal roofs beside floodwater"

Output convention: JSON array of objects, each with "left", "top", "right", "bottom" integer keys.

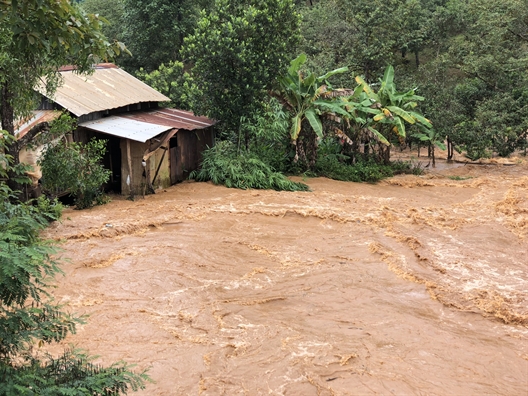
[{"left": 36, "top": 63, "right": 215, "bottom": 195}]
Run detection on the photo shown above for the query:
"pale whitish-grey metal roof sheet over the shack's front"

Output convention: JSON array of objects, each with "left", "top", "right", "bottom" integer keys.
[{"left": 79, "top": 116, "right": 173, "bottom": 143}]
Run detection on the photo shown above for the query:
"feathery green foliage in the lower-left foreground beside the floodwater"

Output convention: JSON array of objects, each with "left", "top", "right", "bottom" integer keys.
[{"left": 0, "top": 134, "right": 148, "bottom": 396}]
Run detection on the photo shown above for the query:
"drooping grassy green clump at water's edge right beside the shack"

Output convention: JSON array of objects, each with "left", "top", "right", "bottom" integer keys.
[{"left": 189, "top": 141, "right": 309, "bottom": 191}]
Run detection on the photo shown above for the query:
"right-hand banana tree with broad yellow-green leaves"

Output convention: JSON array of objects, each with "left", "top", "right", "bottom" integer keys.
[{"left": 353, "top": 66, "right": 432, "bottom": 163}]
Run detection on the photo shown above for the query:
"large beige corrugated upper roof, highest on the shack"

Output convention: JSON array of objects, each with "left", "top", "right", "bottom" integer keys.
[{"left": 37, "top": 64, "right": 170, "bottom": 117}]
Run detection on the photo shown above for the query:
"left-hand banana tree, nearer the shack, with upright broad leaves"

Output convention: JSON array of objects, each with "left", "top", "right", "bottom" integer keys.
[{"left": 272, "top": 54, "right": 348, "bottom": 166}]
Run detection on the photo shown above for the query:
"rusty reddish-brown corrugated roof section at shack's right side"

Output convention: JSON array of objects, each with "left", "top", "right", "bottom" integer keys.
[{"left": 119, "top": 109, "right": 216, "bottom": 131}]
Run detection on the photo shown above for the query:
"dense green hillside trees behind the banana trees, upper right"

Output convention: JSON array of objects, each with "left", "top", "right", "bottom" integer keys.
[{"left": 294, "top": 0, "right": 528, "bottom": 159}]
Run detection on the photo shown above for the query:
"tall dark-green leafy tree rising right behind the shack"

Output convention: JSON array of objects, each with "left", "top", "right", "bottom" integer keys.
[{"left": 182, "top": 0, "right": 300, "bottom": 147}]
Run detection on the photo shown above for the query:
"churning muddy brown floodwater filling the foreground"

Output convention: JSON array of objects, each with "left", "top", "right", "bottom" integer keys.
[{"left": 46, "top": 164, "right": 528, "bottom": 396}]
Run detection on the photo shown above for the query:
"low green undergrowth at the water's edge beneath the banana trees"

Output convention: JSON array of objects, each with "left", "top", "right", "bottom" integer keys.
[{"left": 313, "top": 155, "right": 423, "bottom": 183}]
